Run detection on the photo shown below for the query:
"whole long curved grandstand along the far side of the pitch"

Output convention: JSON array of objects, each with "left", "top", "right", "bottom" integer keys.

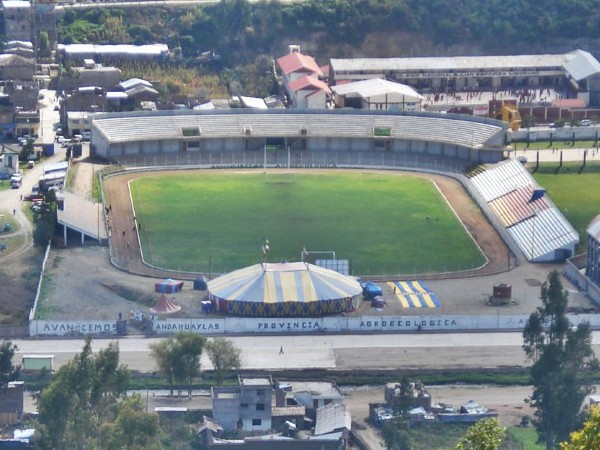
[{"left": 92, "top": 110, "right": 506, "bottom": 165}]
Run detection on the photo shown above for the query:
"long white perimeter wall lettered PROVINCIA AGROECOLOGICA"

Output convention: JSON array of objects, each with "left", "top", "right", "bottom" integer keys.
[{"left": 29, "top": 314, "right": 600, "bottom": 336}]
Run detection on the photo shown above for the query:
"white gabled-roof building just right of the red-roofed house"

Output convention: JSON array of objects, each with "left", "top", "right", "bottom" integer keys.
[{"left": 331, "top": 78, "right": 423, "bottom": 111}]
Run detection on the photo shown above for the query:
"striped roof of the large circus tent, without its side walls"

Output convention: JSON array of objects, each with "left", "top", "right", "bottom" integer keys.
[{"left": 208, "top": 262, "right": 362, "bottom": 303}]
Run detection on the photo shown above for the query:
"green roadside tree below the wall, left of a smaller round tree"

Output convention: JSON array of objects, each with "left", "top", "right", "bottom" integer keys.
[{"left": 150, "top": 331, "right": 206, "bottom": 396}]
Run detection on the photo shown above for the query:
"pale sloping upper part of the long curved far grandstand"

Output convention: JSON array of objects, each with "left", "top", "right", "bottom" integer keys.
[{"left": 92, "top": 109, "right": 506, "bottom": 148}]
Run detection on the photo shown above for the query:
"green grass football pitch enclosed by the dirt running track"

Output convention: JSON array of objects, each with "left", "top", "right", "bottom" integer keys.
[{"left": 131, "top": 172, "right": 485, "bottom": 275}]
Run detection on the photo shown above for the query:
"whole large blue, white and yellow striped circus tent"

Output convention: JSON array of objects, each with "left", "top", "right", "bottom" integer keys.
[{"left": 208, "top": 262, "right": 362, "bottom": 317}]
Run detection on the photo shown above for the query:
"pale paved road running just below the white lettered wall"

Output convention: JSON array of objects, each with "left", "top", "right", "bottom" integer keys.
[{"left": 13, "top": 331, "right": 600, "bottom": 372}]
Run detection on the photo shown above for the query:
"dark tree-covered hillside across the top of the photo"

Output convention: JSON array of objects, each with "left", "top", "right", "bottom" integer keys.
[{"left": 59, "top": 0, "right": 600, "bottom": 66}]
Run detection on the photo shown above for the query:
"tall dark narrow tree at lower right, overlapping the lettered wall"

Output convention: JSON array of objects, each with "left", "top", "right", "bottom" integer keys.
[{"left": 523, "top": 271, "right": 598, "bottom": 450}]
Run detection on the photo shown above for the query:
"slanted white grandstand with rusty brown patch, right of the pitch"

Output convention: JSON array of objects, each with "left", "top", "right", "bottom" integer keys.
[{"left": 471, "top": 159, "right": 579, "bottom": 262}]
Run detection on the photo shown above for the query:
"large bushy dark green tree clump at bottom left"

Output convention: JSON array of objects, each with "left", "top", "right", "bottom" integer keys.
[{"left": 36, "top": 336, "right": 159, "bottom": 450}]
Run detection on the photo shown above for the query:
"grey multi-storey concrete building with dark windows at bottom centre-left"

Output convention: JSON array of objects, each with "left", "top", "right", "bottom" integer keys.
[{"left": 212, "top": 376, "right": 273, "bottom": 432}]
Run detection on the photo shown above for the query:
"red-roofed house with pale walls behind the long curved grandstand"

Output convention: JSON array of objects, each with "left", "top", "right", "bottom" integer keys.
[{"left": 277, "top": 45, "right": 331, "bottom": 109}]
